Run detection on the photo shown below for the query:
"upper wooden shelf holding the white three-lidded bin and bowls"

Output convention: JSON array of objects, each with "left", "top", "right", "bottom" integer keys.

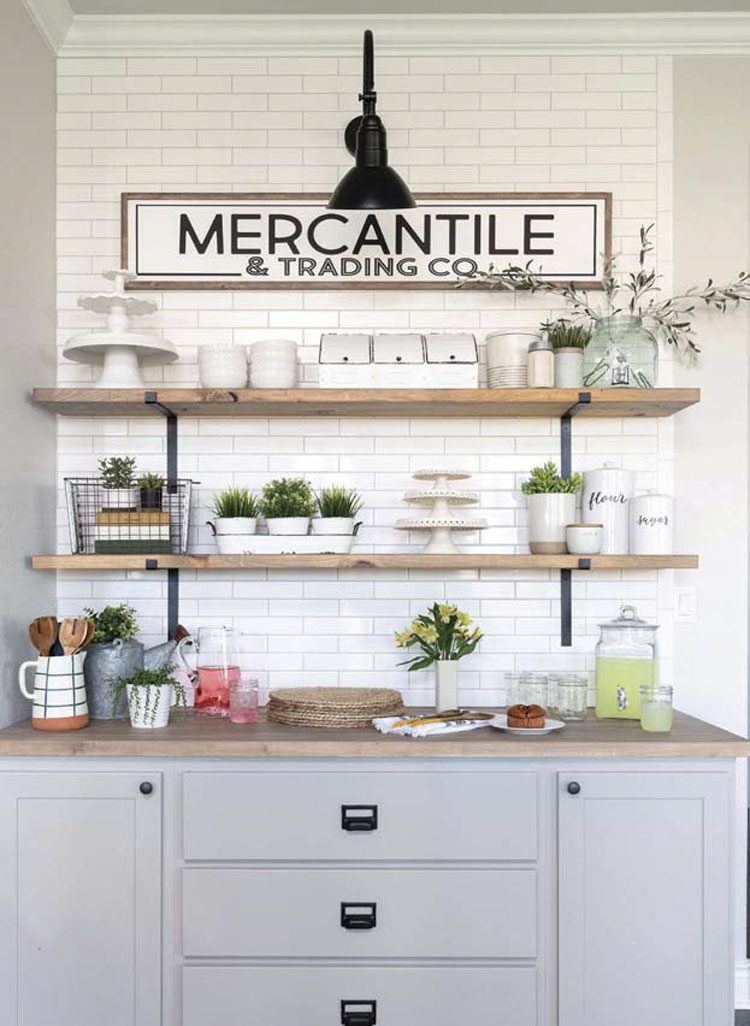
[{"left": 33, "top": 388, "right": 701, "bottom": 417}]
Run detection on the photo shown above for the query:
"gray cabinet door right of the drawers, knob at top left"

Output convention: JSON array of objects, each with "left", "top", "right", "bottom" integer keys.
[{"left": 558, "top": 771, "right": 733, "bottom": 1026}]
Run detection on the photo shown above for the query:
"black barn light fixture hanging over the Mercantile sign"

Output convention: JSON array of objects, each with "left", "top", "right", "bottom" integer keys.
[{"left": 328, "top": 29, "right": 417, "bottom": 210}]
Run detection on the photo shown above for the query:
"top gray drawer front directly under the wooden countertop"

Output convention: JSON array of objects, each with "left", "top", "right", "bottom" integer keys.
[{"left": 183, "top": 770, "right": 537, "bottom": 862}]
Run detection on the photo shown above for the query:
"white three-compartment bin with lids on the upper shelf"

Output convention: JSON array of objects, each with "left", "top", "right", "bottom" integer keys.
[{"left": 318, "top": 332, "right": 479, "bottom": 388}]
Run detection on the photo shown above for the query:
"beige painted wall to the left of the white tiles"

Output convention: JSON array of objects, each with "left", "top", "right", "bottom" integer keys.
[{"left": 0, "top": 0, "right": 55, "bottom": 725}]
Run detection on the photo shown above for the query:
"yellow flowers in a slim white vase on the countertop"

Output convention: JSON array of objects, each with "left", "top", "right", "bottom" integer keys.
[{"left": 396, "top": 602, "right": 482, "bottom": 712}]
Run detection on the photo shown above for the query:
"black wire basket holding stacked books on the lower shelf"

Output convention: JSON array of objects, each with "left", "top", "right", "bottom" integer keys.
[{"left": 65, "top": 477, "right": 193, "bottom": 556}]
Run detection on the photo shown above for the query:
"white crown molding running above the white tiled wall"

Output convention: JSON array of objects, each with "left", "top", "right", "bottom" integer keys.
[{"left": 24, "top": 9, "right": 750, "bottom": 57}]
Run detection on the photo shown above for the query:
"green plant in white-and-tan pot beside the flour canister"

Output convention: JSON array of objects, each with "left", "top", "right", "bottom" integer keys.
[{"left": 521, "top": 460, "right": 584, "bottom": 555}]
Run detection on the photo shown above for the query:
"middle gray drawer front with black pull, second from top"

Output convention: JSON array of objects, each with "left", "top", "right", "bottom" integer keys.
[{"left": 183, "top": 868, "right": 537, "bottom": 958}]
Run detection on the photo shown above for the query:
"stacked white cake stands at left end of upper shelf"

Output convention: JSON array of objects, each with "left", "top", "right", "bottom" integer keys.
[{"left": 63, "top": 269, "right": 177, "bottom": 388}]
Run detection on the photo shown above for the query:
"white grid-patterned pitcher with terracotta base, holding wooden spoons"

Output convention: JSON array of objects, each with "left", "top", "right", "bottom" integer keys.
[{"left": 18, "top": 652, "right": 88, "bottom": 731}]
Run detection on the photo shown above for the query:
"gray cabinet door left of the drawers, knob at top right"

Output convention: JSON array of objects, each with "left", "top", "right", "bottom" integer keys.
[{"left": 0, "top": 771, "right": 161, "bottom": 1026}]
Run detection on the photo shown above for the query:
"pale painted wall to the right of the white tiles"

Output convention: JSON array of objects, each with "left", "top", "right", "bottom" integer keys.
[{"left": 674, "top": 57, "right": 750, "bottom": 962}]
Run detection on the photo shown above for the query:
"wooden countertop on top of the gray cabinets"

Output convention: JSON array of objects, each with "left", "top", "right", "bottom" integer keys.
[{"left": 0, "top": 712, "right": 750, "bottom": 759}]
